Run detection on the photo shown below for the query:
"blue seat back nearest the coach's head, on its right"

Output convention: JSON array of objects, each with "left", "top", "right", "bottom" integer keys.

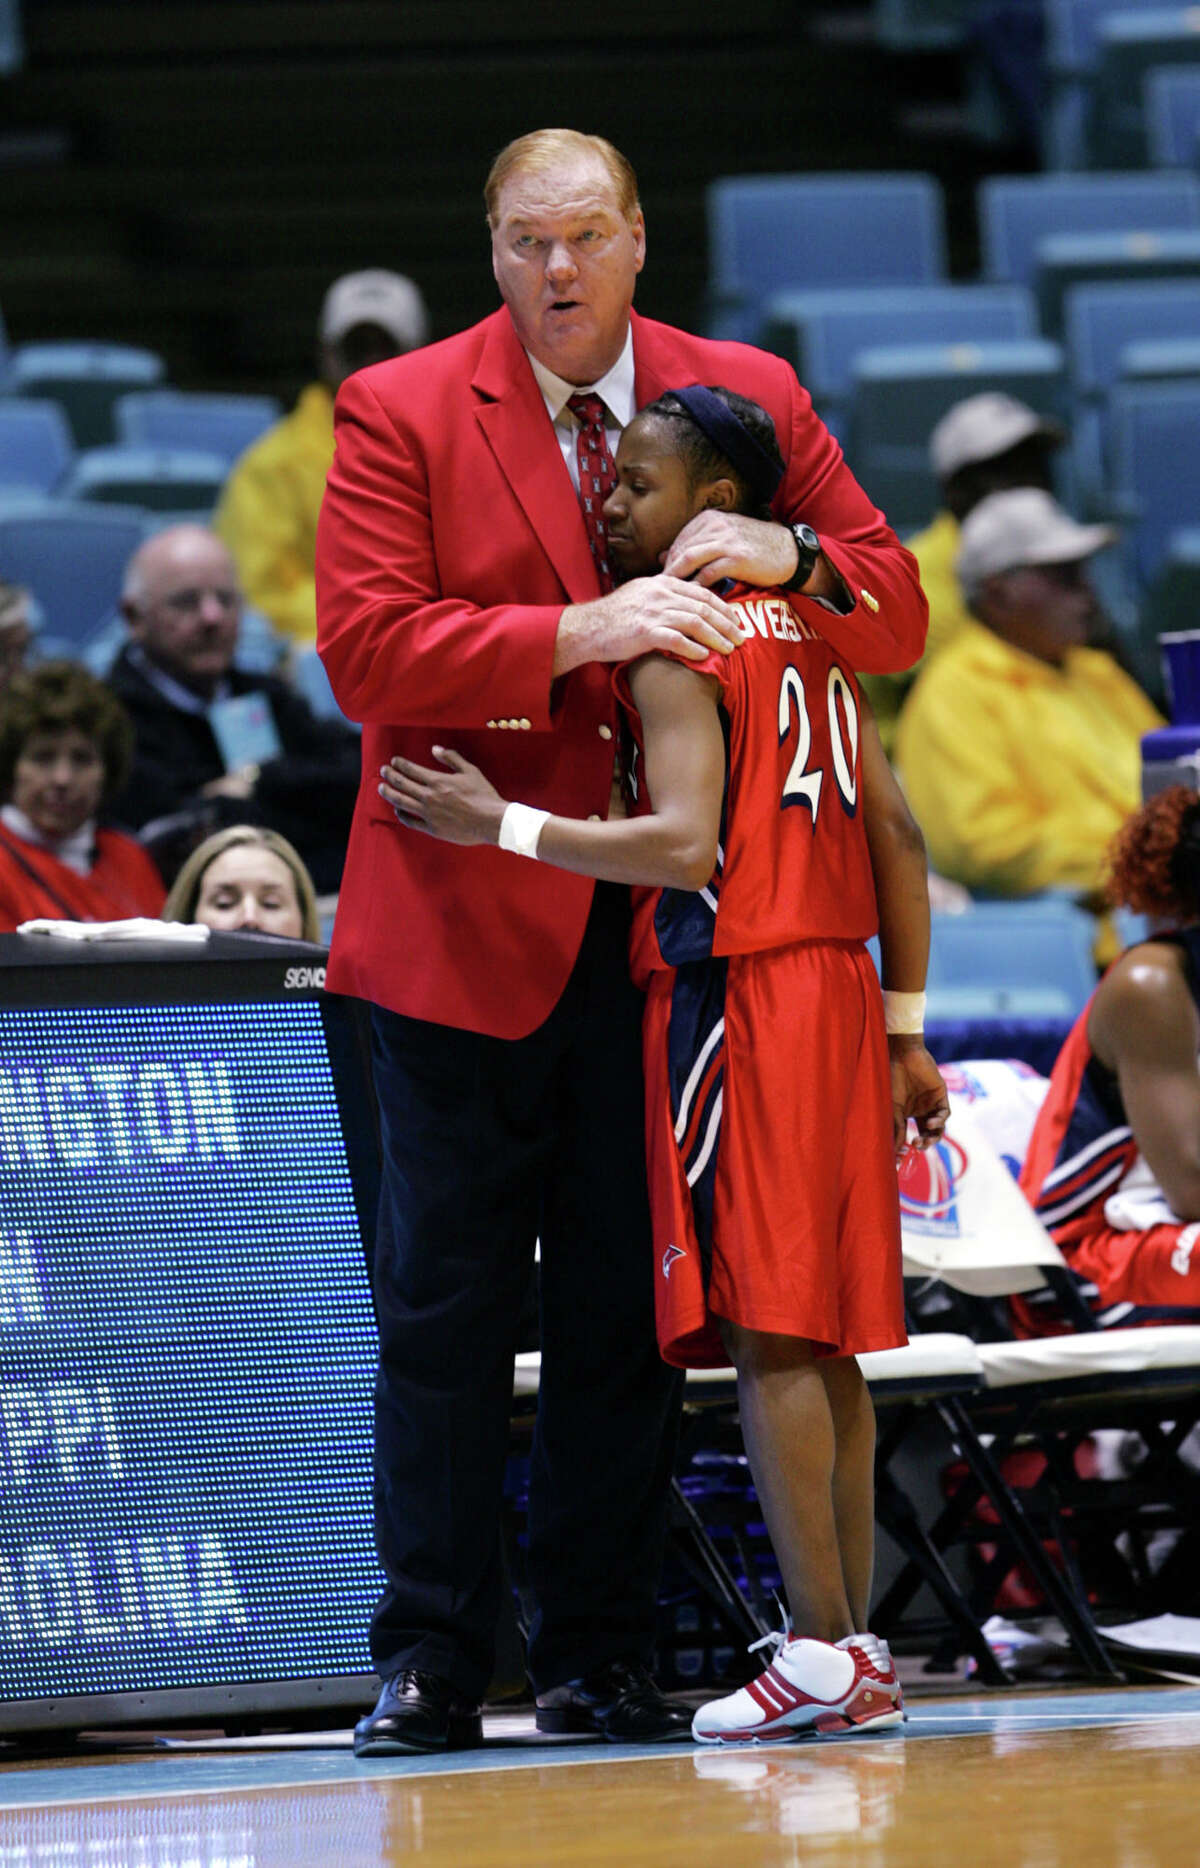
[{"left": 705, "top": 170, "right": 946, "bottom": 340}]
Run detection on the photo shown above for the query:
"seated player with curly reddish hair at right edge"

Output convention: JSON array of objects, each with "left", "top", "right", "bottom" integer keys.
[{"left": 1019, "top": 785, "right": 1200, "bottom": 1334}]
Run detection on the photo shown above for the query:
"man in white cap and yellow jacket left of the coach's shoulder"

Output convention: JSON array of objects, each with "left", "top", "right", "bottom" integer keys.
[{"left": 213, "top": 267, "right": 430, "bottom": 643}]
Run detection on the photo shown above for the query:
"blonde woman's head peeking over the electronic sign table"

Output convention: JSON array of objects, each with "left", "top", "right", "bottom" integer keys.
[{"left": 163, "top": 824, "right": 321, "bottom": 941}]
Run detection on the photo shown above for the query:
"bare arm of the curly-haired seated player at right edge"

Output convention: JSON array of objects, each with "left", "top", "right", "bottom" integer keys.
[{"left": 1088, "top": 941, "right": 1200, "bottom": 1220}]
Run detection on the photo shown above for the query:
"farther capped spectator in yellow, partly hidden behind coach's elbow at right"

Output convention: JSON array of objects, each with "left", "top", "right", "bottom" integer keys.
[{"left": 860, "top": 390, "right": 1065, "bottom": 755}]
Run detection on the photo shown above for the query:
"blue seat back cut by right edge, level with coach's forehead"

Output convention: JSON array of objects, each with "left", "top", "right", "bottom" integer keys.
[{"left": 976, "top": 170, "right": 1200, "bottom": 286}]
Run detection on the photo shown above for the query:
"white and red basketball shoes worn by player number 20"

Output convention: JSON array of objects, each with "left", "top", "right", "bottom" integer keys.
[{"left": 692, "top": 1636, "right": 905, "bottom": 1745}]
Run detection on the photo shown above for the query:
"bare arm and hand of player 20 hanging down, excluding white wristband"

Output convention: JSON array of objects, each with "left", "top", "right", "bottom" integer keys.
[{"left": 860, "top": 697, "right": 950, "bottom": 1153}]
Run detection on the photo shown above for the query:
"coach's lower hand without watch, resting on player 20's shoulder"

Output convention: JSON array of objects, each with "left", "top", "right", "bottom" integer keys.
[{"left": 553, "top": 579, "right": 743, "bottom": 674}]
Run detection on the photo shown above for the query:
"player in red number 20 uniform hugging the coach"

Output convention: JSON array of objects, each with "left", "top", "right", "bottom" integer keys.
[{"left": 379, "top": 387, "right": 946, "bottom": 1743}]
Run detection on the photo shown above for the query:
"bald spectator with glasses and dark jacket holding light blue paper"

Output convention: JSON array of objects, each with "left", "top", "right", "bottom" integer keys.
[{"left": 108, "top": 525, "right": 359, "bottom": 893}]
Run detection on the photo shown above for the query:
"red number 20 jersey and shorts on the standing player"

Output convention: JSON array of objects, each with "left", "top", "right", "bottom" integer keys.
[{"left": 615, "top": 587, "right": 907, "bottom": 1367}]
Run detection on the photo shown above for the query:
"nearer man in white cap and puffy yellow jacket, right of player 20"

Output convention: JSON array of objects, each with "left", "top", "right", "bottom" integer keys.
[{"left": 895, "top": 488, "right": 1161, "bottom": 930}]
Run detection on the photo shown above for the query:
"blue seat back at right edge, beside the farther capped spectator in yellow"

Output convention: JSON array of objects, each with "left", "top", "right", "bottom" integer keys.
[{"left": 1110, "top": 379, "right": 1200, "bottom": 579}]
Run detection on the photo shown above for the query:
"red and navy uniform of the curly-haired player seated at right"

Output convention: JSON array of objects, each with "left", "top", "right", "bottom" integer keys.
[{"left": 1013, "top": 928, "right": 1200, "bottom": 1336}]
